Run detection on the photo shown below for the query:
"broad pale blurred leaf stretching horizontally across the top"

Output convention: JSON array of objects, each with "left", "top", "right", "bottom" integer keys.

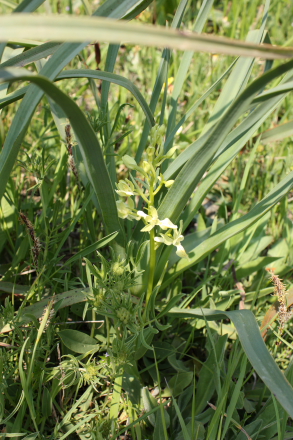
[{"left": 0, "top": 14, "right": 293, "bottom": 59}]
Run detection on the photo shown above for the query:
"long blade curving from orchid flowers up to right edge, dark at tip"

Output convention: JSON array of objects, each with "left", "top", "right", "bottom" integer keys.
[{"left": 158, "top": 61, "right": 293, "bottom": 223}]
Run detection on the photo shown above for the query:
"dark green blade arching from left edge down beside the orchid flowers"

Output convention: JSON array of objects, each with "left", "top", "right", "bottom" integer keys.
[{"left": 0, "top": 68, "right": 124, "bottom": 245}]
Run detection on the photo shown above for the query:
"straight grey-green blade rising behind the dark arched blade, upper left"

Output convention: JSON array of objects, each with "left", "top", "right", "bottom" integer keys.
[{"left": 0, "top": 0, "right": 144, "bottom": 200}]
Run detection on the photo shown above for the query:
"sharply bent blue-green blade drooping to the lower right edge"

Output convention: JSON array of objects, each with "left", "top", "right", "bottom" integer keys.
[{"left": 169, "top": 307, "right": 293, "bottom": 417}]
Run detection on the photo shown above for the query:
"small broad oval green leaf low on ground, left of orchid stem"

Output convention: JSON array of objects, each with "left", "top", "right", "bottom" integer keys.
[{"left": 58, "top": 330, "right": 99, "bottom": 353}]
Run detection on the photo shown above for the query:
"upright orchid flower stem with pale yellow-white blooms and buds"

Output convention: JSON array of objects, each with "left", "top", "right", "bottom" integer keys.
[{"left": 116, "top": 125, "right": 188, "bottom": 310}]
